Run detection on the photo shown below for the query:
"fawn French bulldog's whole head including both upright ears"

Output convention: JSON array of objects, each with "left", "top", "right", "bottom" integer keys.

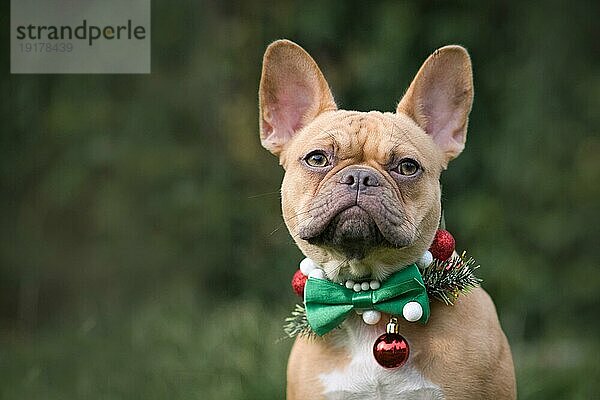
[{"left": 259, "top": 40, "right": 473, "bottom": 281}]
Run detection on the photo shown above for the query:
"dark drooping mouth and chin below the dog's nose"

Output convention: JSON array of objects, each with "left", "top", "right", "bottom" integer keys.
[{"left": 301, "top": 205, "right": 401, "bottom": 260}]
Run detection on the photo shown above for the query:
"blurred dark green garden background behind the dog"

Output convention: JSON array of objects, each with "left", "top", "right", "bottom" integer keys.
[{"left": 0, "top": 1, "right": 600, "bottom": 399}]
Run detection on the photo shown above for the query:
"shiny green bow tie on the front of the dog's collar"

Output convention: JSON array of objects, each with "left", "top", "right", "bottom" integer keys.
[{"left": 304, "top": 264, "right": 429, "bottom": 336}]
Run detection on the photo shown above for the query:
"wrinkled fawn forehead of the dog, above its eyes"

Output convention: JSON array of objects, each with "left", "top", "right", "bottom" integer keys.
[{"left": 286, "top": 111, "right": 435, "bottom": 164}]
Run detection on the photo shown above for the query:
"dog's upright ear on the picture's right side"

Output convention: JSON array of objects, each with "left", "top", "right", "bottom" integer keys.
[{"left": 396, "top": 46, "right": 473, "bottom": 166}]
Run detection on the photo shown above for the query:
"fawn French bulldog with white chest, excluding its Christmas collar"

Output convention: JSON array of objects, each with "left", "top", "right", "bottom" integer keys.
[{"left": 259, "top": 40, "right": 516, "bottom": 400}]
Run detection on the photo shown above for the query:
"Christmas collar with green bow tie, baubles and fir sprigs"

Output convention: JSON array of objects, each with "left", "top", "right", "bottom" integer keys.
[{"left": 284, "top": 229, "right": 481, "bottom": 368}]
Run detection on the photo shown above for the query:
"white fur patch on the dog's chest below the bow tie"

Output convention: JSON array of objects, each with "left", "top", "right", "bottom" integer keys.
[{"left": 319, "top": 318, "right": 444, "bottom": 400}]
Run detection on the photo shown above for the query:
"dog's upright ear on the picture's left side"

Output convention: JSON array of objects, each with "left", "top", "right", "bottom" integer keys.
[{"left": 258, "top": 40, "right": 337, "bottom": 155}]
